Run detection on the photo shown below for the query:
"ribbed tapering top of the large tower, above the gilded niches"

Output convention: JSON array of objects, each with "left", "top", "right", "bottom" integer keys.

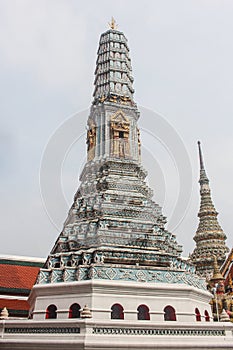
[{"left": 93, "top": 23, "right": 135, "bottom": 106}]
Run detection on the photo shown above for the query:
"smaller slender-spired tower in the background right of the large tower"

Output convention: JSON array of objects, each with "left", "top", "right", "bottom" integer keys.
[{"left": 190, "top": 141, "right": 229, "bottom": 279}]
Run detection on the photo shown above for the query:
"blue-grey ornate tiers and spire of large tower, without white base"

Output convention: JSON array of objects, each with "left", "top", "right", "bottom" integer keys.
[{"left": 36, "top": 19, "right": 195, "bottom": 283}]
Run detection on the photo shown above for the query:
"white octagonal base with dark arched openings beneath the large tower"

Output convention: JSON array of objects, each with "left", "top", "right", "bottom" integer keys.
[{"left": 29, "top": 280, "right": 211, "bottom": 322}]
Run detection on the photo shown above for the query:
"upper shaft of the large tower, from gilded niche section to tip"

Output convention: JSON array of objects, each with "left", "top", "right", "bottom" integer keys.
[{"left": 87, "top": 25, "right": 138, "bottom": 163}]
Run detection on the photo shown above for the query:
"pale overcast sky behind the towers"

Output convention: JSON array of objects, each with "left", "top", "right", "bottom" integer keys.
[{"left": 0, "top": 0, "right": 233, "bottom": 257}]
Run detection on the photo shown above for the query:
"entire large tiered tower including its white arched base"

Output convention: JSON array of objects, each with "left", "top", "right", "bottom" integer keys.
[{"left": 30, "top": 22, "right": 209, "bottom": 326}]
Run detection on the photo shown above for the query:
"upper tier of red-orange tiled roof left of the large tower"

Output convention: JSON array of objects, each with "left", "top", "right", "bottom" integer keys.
[{"left": 0, "top": 263, "right": 40, "bottom": 290}]
